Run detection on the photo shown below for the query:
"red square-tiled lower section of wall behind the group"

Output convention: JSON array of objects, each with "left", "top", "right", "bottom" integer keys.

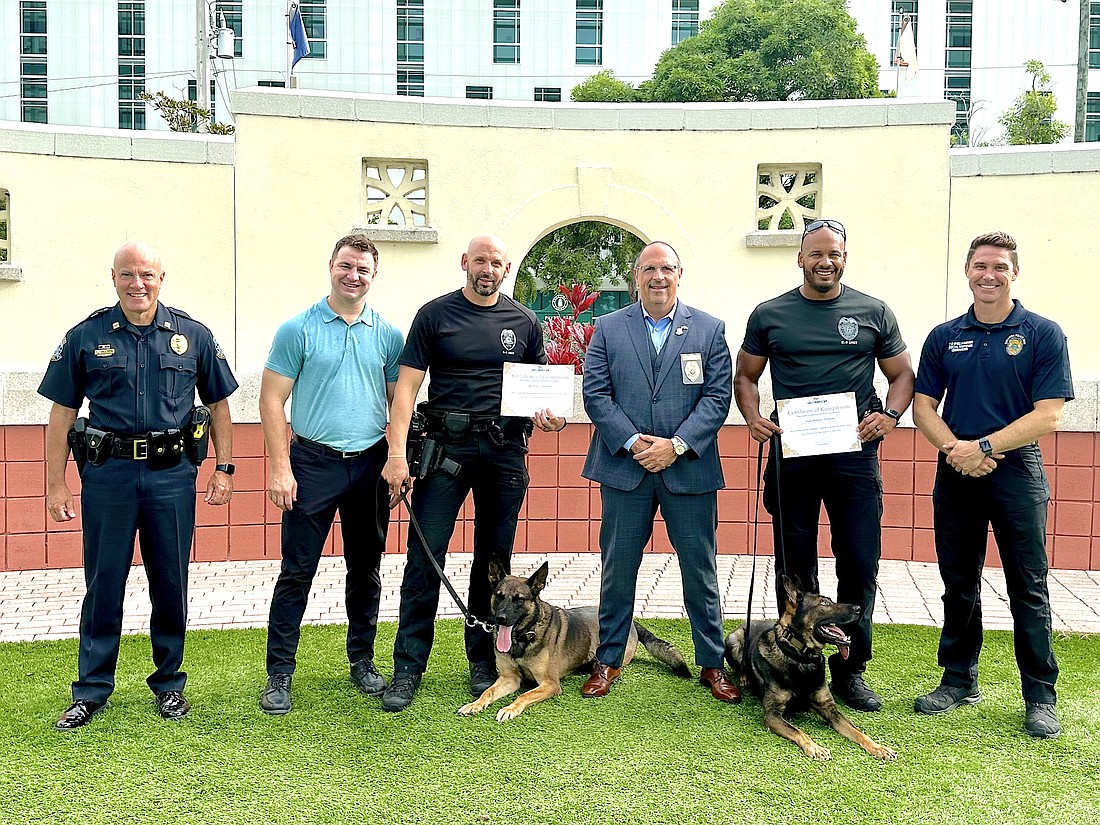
[{"left": 0, "top": 424, "right": 1100, "bottom": 571}]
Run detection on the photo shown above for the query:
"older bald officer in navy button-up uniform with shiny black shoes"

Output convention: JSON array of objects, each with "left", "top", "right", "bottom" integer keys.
[{"left": 39, "top": 243, "right": 237, "bottom": 730}]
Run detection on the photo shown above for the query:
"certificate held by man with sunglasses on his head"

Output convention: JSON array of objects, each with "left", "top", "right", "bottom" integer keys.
[{"left": 776, "top": 393, "right": 862, "bottom": 459}]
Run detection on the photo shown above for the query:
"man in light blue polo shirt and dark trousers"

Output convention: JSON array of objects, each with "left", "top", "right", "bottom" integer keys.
[{"left": 260, "top": 234, "right": 404, "bottom": 715}]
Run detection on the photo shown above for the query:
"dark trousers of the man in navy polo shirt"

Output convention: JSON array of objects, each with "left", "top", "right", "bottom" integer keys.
[{"left": 933, "top": 444, "right": 1058, "bottom": 703}]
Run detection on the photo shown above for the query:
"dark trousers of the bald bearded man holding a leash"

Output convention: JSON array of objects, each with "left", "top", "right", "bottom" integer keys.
[{"left": 394, "top": 432, "right": 529, "bottom": 674}]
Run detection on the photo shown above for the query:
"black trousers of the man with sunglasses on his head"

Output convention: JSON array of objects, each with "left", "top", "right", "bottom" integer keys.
[{"left": 763, "top": 441, "right": 882, "bottom": 679}]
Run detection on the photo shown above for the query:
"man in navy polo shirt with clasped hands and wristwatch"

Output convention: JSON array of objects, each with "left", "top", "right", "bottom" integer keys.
[{"left": 913, "top": 232, "right": 1074, "bottom": 738}]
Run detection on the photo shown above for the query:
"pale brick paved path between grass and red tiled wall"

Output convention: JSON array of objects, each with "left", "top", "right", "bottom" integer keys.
[{"left": 0, "top": 553, "right": 1100, "bottom": 641}]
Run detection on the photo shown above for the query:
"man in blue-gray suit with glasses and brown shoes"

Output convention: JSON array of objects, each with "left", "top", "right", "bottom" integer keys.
[{"left": 582, "top": 241, "right": 740, "bottom": 702}]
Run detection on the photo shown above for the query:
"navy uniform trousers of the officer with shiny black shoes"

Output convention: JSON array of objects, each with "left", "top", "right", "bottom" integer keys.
[{"left": 73, "top": 459, "right": 197, "bottom": 703}]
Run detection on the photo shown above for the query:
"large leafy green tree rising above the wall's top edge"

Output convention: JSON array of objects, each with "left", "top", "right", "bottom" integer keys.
[{"left": 574, "top": 0, "right": 882, "bottom": 102}]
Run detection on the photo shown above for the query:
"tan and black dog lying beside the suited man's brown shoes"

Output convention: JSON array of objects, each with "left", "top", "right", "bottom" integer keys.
[{"left": 459, "top": 559, "right": 691, "bottom": 722}]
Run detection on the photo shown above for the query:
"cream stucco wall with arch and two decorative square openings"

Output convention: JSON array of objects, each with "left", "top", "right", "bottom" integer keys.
[{"left": 0, "top": 98, "right": 1100, "bottom": 430}]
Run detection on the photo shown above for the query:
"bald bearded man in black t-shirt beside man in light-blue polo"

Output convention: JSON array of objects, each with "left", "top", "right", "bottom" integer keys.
[{"left": 382, "top": 235, "right": 565, "bottom": 712}]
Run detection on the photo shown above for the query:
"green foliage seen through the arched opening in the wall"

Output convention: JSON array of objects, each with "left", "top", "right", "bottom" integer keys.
[{"left": 515, "top": 221, "right": 645, "bottom": 303}]
